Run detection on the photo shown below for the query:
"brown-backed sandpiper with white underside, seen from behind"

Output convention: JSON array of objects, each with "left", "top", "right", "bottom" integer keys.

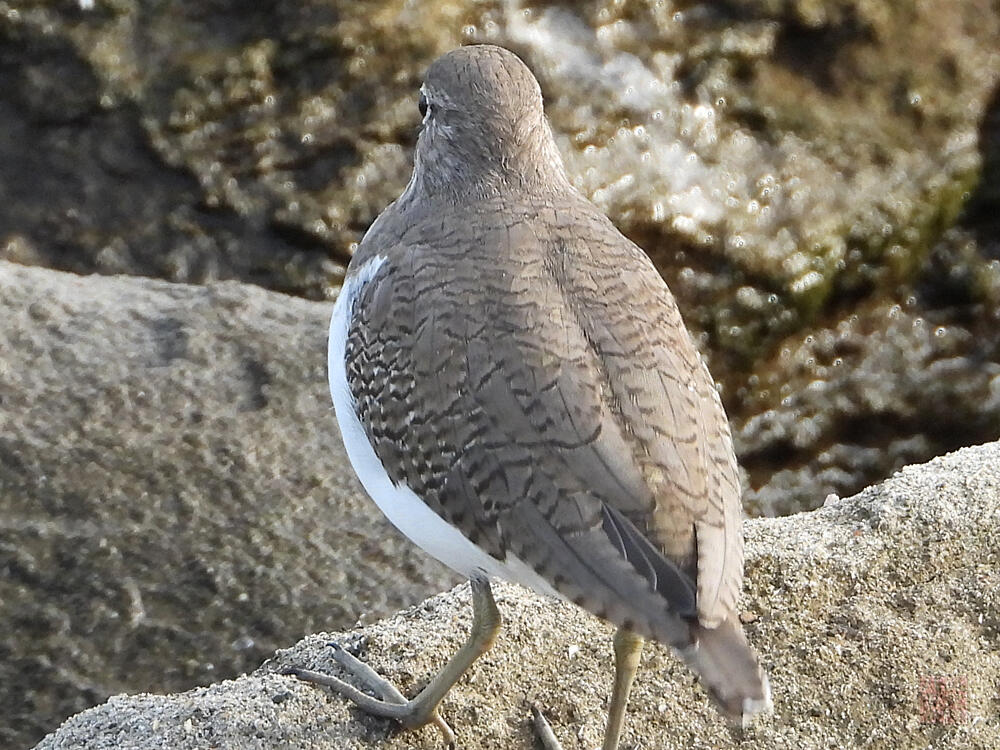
[{"left": 290, "top": 45, "right": 771, "bottom": 750}]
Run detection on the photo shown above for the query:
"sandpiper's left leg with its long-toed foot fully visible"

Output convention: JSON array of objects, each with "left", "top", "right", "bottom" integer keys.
[{"left": 284, "top": 578, "right": 500, "bottom": 744}]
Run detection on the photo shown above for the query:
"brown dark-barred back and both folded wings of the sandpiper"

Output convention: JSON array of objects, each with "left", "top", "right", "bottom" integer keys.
[{"left": 347, "top": 209, "right": 742, "bottom": 642}]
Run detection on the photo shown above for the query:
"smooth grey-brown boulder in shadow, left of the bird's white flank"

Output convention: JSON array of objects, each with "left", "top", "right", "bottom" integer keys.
[{"left": 0, "top": 262, "right": 457, "bottom": 747}]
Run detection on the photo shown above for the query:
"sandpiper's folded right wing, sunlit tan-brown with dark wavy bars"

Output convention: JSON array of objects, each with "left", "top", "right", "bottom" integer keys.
[{"left": 555, "top": 204, "right": 743, "bottom": 627}]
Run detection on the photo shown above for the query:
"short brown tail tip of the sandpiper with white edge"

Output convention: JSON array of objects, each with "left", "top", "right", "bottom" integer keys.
[{"left": 679, "top": 616, "right": 772, "bottom": 726}]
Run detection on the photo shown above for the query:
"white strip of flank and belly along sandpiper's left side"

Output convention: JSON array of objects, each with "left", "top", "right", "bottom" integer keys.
[{"left": 328, "top": 256, "right": 560, "bottom": 597}]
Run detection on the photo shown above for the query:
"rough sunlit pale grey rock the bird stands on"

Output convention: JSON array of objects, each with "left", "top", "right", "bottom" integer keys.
[{"left": 31, "top": 443, "right": 1000, "bottom": 750}]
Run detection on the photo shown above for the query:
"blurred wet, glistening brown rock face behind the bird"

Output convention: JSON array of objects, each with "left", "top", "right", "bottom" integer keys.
[{"left": 0, "top": 0, "right": 1000, "bottom": 524}]
